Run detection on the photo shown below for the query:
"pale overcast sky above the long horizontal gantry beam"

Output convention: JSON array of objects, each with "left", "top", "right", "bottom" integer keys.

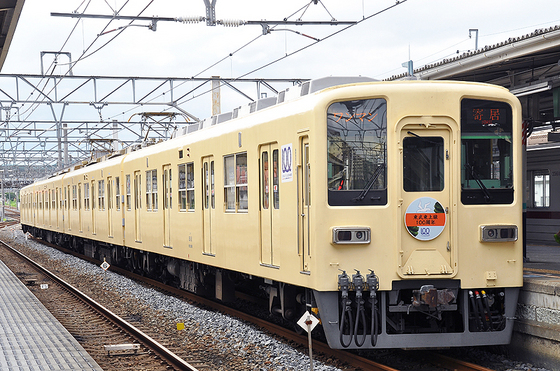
[{"left": 2, "top": 0, "right": 560, "bottom": 117}]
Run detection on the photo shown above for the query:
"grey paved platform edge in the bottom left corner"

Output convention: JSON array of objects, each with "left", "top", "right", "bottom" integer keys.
[{"left": 0, "top": 261, "right": 102, "bottom": 371}]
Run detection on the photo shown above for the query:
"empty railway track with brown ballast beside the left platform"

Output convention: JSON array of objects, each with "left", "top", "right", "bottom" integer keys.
[{"left": 0, "top": 241, "right": 208, "bottom": 371}]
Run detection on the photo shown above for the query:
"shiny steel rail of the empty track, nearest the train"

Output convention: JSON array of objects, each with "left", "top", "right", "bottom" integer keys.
[{"left": 0, "top": 240, "right": 198, "bottom": 371}]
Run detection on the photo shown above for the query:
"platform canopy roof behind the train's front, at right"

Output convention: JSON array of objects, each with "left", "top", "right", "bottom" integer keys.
[{"left": 388, "top": 25, "right": 560, "bottom": 127}]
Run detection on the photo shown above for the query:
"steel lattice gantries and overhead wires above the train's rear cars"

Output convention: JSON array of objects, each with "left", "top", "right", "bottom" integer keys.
[{"left": 0, "top": 74, "right": 307, "bottom": 188}]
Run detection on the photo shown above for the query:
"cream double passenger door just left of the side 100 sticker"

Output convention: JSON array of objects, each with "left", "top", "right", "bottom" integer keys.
[{"left": 260, "top": 144, "right": 280, "bottom": 265}]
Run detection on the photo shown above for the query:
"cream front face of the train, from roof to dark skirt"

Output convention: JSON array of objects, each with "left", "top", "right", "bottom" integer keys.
[{"left": 312, "top": 82, "right": 523, "bottom": 349}]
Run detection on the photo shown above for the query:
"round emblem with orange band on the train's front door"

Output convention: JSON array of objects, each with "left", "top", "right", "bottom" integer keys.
[{"left": 404, "top": 197, "right": 446, "bottom": 241}]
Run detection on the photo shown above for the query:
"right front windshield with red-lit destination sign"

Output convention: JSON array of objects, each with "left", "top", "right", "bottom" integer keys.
[{"left": 461, "top": 99, "right": 513, "bottom": 205}]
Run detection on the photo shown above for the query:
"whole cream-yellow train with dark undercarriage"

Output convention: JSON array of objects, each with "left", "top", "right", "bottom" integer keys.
[{"left": 21, "top": 78, "right": 523, "bottom": 349}]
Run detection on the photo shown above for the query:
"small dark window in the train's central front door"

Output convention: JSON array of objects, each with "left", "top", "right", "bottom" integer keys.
[{"left": 403, "top": 136, "right": 444, "bottom": 192}]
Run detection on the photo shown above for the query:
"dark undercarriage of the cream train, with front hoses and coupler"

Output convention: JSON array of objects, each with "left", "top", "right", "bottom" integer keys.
[{"left": 22, "top": 225, "right": 519, "bottom": 349}]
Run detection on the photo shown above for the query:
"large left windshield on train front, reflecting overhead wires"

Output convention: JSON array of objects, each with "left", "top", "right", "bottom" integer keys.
[{"left": 327, "top": 99, "right": 387, "bottom": 206}]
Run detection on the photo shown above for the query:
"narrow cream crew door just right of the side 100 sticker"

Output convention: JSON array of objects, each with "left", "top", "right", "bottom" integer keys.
[{"left": 298, "top": 137, "right": 311, "bottom": 272}]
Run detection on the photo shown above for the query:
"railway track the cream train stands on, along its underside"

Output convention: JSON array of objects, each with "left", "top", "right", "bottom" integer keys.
[{"left": 6, "top": 231, "right": 492, "bottom": 371}]
